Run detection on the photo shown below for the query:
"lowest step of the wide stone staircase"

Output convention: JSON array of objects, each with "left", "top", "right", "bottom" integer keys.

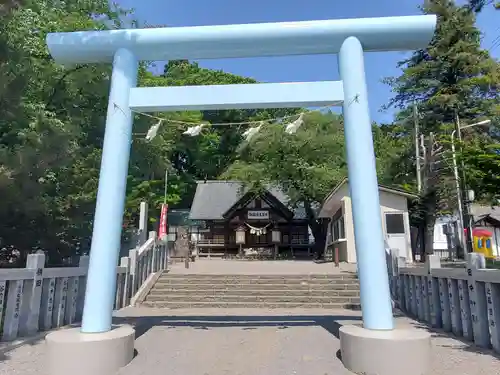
[{"left": 142, "top": 301, "right": 360, "bottom": 310}]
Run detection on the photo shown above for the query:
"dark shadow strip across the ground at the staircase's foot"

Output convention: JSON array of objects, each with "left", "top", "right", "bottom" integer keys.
[{"left": 114, "top": 315, "right": 361, "bottom": 338}]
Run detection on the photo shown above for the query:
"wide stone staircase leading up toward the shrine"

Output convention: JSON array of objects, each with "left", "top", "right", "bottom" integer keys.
[{"left": 142, "top": 273, "right": 360, "bottom": 310}]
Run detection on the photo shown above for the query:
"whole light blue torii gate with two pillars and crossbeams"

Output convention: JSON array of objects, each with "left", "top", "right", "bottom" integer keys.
[{"left": 47, "top": 15, "right": 436, "bottom": 371}]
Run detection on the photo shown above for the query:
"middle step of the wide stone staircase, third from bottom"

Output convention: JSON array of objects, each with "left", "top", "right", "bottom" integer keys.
[{"left": 149, "top": 287, "right": 359, "bottom": 298}]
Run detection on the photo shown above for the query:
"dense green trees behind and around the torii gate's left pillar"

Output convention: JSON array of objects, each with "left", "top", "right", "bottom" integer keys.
[{"left": 0, "top": 0, "right": 293, "bottom": 263}]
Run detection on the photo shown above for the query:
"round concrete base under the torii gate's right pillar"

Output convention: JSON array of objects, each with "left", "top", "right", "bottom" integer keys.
[{"left": 339, "top": 325, "right": 431, "bottom": 375}]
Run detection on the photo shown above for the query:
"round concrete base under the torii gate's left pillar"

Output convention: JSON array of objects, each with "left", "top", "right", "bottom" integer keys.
[{"left": 45, "top": 325, "right": 135, "bottom": 375}]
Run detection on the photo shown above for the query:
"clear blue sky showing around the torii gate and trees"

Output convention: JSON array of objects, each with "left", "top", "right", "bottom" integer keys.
[{"left": 117, "top": 0, "right": 500, "bottom": 122}]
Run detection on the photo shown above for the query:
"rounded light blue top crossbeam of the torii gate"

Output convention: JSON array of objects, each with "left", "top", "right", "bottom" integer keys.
[{"left": 47, "top": 15, "right": 436, "bottom": 64}]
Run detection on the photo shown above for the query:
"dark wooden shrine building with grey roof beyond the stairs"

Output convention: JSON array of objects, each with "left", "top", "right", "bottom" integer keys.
[{"left": 189, "top": 180, "right": 313, "bottom": 258}]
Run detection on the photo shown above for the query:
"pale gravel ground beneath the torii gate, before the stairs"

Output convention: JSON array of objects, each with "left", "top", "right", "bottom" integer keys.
[{"left": 0, "top": 308, "right": 500, "bottom": 375}]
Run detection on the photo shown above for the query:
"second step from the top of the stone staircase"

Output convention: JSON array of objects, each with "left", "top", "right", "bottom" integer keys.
[{"left": 154, "top": 280, "right": 359, "bottom": 291}]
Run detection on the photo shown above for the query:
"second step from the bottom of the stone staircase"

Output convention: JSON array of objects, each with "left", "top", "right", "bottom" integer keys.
[{"left": 146, "top": 294, "right": 359, "bottom": 304}]
